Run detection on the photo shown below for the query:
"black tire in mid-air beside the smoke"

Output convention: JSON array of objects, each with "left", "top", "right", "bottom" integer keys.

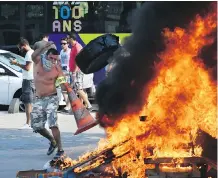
[{"left": 75, "top": 34, "right": 120, "bottom": 74}]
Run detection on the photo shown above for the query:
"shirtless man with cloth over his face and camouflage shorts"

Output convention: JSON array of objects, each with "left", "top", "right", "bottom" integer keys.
[{"left": 31, "top": 43, "right": 64, "bottom": 157}]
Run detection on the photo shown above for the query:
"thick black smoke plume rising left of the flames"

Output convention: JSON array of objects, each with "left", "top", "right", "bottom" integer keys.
[{"left": 96, "top": 1, "right": 216, "bottom": 125}]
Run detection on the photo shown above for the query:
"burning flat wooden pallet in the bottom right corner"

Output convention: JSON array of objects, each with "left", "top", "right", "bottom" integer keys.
[{"left": 144, "top": 157, "right": 216, "bottom": 178}]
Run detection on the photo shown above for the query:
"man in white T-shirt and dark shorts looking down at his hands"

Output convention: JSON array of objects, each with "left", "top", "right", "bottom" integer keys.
[{"left": 11, "top": 38, "right": 35, "bottom": 129}]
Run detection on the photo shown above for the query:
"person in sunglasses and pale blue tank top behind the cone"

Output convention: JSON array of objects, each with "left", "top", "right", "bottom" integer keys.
[{"left": 60, "top": 38, "right": 71, "bottom": 113}]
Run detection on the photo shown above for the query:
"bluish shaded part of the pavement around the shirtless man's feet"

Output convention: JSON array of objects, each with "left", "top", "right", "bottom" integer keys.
[{"left": 0, "top": 129, "right": 104, "bottom": 178}]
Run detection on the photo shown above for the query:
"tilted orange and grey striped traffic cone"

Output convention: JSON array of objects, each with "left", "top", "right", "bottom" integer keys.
[{"left": 64, "top": 83, "right": 98, "bottom": 135}]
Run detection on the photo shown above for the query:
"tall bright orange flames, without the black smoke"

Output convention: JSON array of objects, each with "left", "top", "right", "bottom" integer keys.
[{"left": 52, "top": 4, "right": 217, "bottom": 178}]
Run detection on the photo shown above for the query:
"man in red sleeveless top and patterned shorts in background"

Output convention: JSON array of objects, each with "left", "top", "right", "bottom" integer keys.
[{"left": 67, "top": 33, "right": 92, "bottom": 111}]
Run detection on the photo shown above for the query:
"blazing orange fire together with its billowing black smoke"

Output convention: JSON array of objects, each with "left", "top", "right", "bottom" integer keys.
[{"left": 63, "top": 2, "right": 217, "bottom": 178}]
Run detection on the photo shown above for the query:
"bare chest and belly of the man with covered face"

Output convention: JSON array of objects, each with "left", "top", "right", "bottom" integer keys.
[{"left": 34, "top": 61, "right": 58, "bottom": 97}]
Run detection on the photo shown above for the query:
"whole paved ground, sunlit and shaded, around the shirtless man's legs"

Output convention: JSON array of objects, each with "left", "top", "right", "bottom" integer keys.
[{"left": 0, "top": 111, "right": 105, "bottom": 178}]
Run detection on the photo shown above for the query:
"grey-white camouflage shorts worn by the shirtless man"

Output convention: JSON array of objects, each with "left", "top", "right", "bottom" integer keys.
[{"left": 31, "top": 95, "right": 59, "bottom": 132}]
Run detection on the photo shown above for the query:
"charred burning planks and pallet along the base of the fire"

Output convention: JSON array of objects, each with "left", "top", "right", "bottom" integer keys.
[{"left": 41, "top": 140, "right": 217, "bottom": 178}]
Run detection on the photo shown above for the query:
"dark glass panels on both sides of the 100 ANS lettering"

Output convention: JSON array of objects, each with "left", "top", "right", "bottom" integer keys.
[{"left": 0, "top": 1, "right": 141, "bottom": 46}]
